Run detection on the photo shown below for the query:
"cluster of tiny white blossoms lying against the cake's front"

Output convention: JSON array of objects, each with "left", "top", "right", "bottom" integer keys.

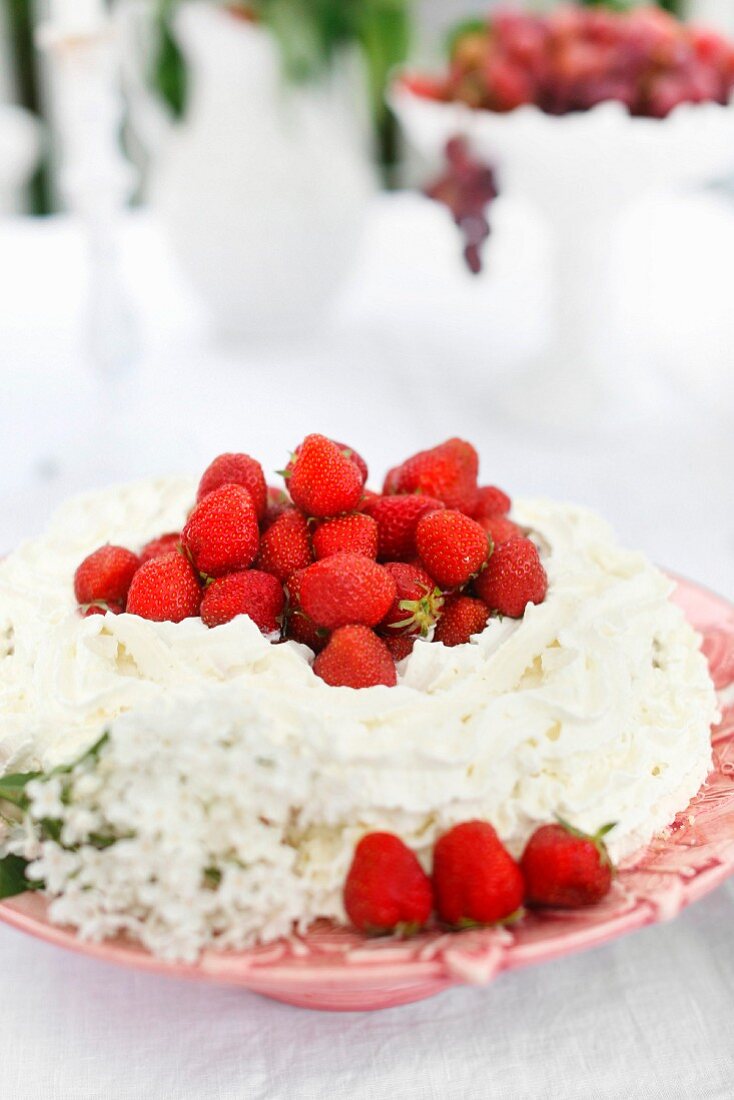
[{"left": 3, "top": 697, "right": 336, "bottom": 960}]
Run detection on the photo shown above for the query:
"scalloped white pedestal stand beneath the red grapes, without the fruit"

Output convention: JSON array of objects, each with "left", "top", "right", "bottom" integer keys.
[{"left": 391, "top": 77, "right": 734, "bottom": 430}]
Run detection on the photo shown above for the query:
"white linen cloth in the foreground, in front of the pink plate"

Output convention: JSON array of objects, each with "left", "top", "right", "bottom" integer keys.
[{"left": 0, "top": 886, "right": 734, "bottom": 1100}]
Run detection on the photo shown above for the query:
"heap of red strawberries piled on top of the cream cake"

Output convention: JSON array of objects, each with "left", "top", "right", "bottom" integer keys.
[{"left": 74, "top": 435, "right": 548, "bottom": 688}]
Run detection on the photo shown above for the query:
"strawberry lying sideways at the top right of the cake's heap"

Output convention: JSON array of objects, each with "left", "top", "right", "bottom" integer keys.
[{"left": 384, "top": 439, "right": 479, "bottom": 512}]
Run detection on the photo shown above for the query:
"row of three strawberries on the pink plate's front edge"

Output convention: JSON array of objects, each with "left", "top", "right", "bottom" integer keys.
[{"left": 344, "top": 821, "right": 613, "bottom": 935}]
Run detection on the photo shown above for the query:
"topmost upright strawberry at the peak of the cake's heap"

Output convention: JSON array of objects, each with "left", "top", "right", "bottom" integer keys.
[{"left": 288, "top": 435, "right": 362, "bottom": 517}]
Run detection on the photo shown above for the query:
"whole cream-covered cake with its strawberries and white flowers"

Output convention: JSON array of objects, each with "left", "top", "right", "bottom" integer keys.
[{"left": 0, "top": 435, "right": 716, "bottom": 958}]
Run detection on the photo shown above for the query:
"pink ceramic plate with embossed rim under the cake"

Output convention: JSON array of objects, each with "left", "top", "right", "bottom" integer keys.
[{"left": 0, "top": 581, "right": 734, "bottom": 1010}]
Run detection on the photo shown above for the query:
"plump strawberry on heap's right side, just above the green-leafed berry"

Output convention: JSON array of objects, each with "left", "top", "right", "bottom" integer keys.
[{"left": 416, "top": 509, "right": 490, "bottom": 589}]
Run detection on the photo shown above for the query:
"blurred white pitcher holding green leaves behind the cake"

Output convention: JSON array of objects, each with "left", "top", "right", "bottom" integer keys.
[{"left": 122, "top": 0, "right": 375, "bottom": 336}]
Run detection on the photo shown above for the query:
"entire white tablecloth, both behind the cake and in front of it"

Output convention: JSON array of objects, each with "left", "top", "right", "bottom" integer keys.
[{"left": 0, "top": 196, "right": 734, "bottom": 1100}]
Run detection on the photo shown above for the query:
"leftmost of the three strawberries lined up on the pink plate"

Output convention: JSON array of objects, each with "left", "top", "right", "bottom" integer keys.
[{"left": 344, "top": 833, "right": 432, "bottom": 934}]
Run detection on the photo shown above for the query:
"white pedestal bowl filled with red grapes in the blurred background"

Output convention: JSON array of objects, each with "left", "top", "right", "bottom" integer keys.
[{"left": 392, "top": 4, "right": 734, "bottom": 425}]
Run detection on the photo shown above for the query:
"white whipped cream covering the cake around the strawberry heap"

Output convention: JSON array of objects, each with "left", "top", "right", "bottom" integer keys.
[{"left": 0, "top": 479, "right": 716, "bottom": 928}]
